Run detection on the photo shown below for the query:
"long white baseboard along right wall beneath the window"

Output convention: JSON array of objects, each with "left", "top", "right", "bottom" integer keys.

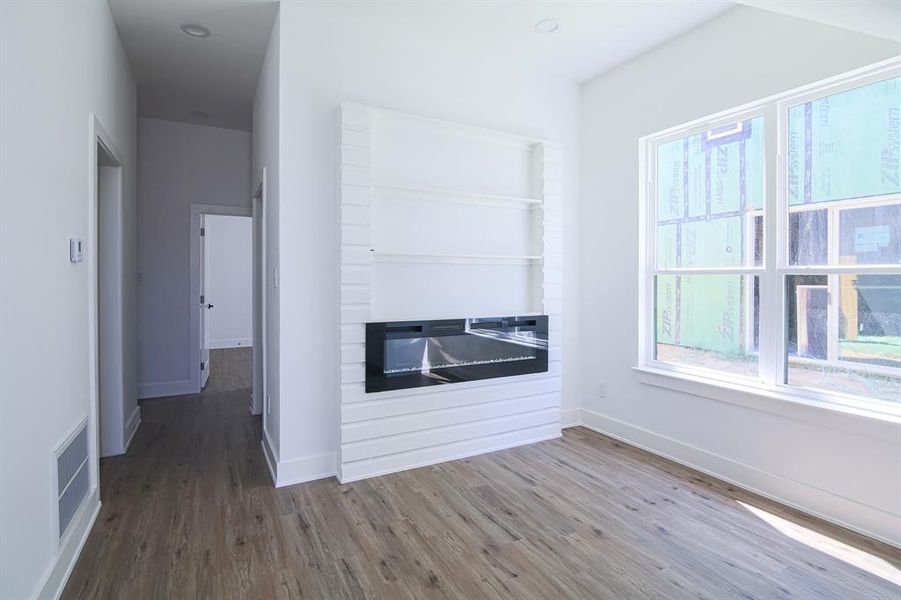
[{"left": 580, "top": 409, "right": 901, "bottom": 548}]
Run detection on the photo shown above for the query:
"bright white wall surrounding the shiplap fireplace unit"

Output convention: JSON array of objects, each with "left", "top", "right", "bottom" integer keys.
[{"left": 279, "top": 2, "right": 579, "bottom": 477}]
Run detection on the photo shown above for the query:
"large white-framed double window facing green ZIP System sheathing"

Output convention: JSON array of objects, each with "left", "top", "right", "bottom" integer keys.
[{"left": 642, "top": 60, "right": 901, "bottom": 412}]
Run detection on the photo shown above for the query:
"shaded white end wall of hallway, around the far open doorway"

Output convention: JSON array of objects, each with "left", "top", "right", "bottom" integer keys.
[{"left": 138, "top": 118, "right": 252, "bottom": 398}]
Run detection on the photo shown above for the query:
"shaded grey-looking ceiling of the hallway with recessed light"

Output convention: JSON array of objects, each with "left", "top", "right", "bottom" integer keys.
[{"left": 109, "top": 0, "right": 278, "bottom": 131}]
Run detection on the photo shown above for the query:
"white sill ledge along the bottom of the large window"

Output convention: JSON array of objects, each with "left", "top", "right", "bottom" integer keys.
[{"left": 633, "top": 366, "right": 901, "bottom": 442}]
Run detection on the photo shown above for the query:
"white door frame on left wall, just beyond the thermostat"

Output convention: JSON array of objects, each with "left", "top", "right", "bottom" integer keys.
[{"left": 85, "top": 113, "right": 125, "bottom": 500}]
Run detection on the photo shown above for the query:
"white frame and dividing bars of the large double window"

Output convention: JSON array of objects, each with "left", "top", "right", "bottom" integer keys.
[{"left": 636, "top": 57, "right": 901, "bottom": 422}]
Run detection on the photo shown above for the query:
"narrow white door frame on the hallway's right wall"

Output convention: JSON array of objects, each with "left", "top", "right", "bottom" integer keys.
[{"left": 250, "top": 167, "right": 267, "bottom": 414}]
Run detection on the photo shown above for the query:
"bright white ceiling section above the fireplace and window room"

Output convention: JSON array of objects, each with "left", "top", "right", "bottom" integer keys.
[{"left": 302, "top": 0, "right": 734, "bottom": 83}]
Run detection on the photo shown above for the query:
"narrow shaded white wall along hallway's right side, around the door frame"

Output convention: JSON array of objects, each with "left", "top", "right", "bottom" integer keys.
[{"left": 252, "top": 11, "right": 280, "bottom": 466}]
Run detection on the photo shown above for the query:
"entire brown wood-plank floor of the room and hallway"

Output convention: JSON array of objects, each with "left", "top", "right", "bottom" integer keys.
[{"left": 63, "top": 390, "right": 901, "bottom": 600}]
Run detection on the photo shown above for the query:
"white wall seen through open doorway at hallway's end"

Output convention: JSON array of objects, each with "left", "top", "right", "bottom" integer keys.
[{"left": 204, "top": 215, "right": 253, "bottom": 348}]
